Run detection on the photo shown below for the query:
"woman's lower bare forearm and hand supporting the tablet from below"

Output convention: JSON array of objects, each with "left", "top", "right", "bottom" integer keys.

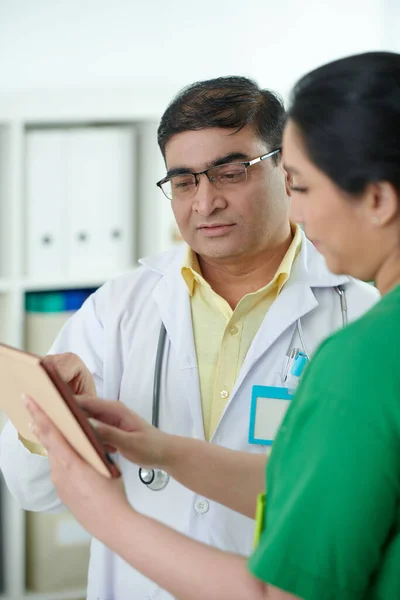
[{"left": 21, "top": 399, "right": 300, "bottom": 600}]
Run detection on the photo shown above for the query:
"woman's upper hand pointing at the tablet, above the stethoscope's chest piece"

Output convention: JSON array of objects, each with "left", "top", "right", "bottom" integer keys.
[{"left": 75, "top": 396, "right": 170, "bottom": 468}]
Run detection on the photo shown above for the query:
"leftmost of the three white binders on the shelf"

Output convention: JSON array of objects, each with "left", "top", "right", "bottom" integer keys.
[{"left": 25, "top": 130, "right": 66, "bottom": 279}]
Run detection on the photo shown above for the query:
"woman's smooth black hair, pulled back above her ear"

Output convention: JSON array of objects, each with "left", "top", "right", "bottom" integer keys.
[{"left": 288, "top": 52, "right": 400, "bottom": 195}]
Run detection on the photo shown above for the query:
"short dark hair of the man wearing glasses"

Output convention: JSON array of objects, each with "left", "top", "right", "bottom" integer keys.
[{"left": 157, "top": 76, "right": 285, "bottom": 162}]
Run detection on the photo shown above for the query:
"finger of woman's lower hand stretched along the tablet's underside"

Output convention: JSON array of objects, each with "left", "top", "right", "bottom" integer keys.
[{"left": 24, "top": 397, "right": 83, "bottom": 469}]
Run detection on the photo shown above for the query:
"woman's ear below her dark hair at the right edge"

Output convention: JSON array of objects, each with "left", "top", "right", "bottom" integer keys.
[{"left": 366, "top": 181, "right": 400, "bottom": 227}]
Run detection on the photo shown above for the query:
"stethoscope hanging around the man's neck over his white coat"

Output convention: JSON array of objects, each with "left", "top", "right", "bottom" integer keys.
[{"left": 139, "top": 285, "right": 348, "bottom": 492}]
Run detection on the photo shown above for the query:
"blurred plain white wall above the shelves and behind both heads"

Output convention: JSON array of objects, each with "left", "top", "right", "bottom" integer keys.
[{"left": 0, "top": 0, "right": 400, "bottom": 254}]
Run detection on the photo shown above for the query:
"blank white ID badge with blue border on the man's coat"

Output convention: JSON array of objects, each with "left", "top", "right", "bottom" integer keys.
[{"left": 249, "top": 385, "right": 294, "bottom": 446}]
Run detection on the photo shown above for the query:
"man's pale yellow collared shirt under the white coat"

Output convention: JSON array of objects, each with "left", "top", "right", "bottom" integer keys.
[{"left": 182, "top": 226, "right": 301, "bottom": 440}]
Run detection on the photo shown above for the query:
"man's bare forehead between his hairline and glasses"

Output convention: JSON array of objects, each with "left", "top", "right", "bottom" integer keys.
[{"left": 165, "top": 125, "right": 266, "bottom": 170}]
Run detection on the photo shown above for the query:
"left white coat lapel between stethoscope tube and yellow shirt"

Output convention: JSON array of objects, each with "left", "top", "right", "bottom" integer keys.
[{"left": 153, "top": 261, "right": 204, "bottom": 439}]
